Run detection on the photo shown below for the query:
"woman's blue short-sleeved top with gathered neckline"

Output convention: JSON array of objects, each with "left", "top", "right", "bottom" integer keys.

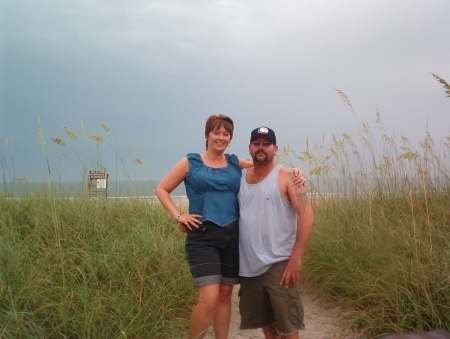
[{"left": 184, "top": 153, "right": 241, "bottom": 226}]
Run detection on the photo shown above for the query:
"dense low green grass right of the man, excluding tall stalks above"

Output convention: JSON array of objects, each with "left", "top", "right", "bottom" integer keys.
[{"left": 302, "top": 192, "right": 450, "bottom": 337}]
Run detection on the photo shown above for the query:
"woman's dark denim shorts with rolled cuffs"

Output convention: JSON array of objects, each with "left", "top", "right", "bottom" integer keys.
[{"left": 185, "top": 220, "right": 239, "bottom": 287}]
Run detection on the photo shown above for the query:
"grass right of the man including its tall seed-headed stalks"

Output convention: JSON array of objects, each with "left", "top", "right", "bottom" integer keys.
[{"left": 280, "top": 81, "right": 450, "bottom": 338}]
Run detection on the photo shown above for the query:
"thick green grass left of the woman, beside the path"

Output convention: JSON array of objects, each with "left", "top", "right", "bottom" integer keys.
[{"left": 0, "top": 192, "right": 195, "bottom": 338}]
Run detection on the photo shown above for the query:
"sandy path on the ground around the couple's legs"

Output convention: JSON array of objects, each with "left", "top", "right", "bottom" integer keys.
[{"left": 206, "top": 286, "right": 358, "bottom": 339}]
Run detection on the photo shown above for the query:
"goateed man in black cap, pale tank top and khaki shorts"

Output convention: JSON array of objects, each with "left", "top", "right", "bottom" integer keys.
[{"left": 238, "top": 127, "right": 314, "bottom": 339}]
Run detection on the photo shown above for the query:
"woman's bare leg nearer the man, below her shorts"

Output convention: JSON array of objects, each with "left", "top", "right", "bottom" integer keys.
[{"left": 213, "top": 284, "right": 233, "bottom": 339}]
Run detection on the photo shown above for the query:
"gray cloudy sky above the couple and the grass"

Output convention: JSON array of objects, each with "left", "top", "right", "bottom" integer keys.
[{"left": 0, "top": 0, "right": 450, "bottom": 185}]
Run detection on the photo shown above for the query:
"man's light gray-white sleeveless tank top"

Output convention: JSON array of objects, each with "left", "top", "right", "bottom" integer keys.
[{"left": 238, "top": 165, "right": 297, "bottom": 277}]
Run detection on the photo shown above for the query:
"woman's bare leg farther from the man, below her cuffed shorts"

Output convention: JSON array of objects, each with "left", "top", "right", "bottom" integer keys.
[{"left": 189, "top": 284, "right": 220, "bottom": 339}]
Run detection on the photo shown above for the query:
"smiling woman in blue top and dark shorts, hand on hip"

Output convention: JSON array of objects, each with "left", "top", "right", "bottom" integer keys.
[{"left": 156, "top": 114, "right": 303, "bottom": 339}]
